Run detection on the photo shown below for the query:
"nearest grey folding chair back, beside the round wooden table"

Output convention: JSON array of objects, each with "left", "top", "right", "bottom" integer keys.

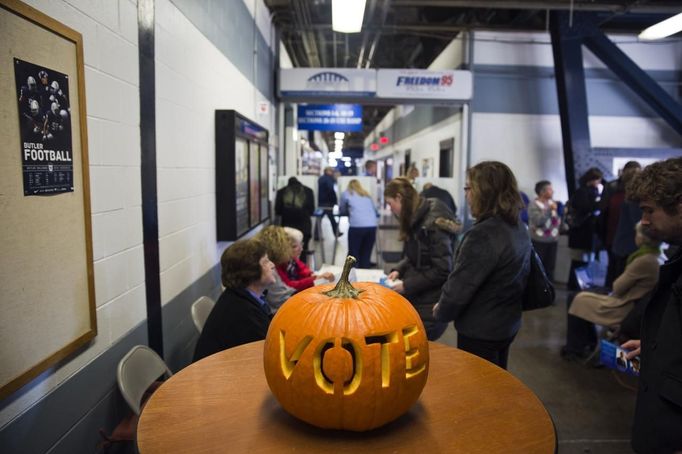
[{"left": 116, "top": 345, "right": 173, "bottom": 415}]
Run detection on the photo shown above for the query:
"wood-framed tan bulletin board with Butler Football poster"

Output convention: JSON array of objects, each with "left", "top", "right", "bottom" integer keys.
[{"left": 0, "top": 0, "right": 97, "bottom": 399}]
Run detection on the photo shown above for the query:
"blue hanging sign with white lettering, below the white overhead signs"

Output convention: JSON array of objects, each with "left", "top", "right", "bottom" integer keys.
[{"left": 298, "top": 104, "right": 362, "bottom": 132}]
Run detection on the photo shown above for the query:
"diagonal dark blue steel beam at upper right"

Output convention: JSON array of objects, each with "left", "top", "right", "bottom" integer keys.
[{"left": 584, "top": 31, "right": 682, "bottom": 135}]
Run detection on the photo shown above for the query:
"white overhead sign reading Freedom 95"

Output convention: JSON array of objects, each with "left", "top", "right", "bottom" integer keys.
[{"left": 377, "top": 69, "right": 473, "bottom": 101}]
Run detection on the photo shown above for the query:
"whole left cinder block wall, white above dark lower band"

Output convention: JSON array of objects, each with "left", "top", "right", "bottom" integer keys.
[{"left": 0, "top": 0, "right": 275, "bottom": 453}]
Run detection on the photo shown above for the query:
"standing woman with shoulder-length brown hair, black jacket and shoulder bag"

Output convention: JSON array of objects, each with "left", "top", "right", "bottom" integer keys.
[{"left": 433, "top": 161, "right": 531, "bottom": 369}]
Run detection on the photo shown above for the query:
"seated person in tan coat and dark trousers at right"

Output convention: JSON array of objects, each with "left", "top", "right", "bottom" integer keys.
[{"left": 561, "top": 223, "right": 661, "bottom": 359}]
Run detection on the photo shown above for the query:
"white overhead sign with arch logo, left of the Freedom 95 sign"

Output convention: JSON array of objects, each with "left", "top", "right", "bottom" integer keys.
[{"left": 279, "top": 68, "right": 377, "bottom": 98}]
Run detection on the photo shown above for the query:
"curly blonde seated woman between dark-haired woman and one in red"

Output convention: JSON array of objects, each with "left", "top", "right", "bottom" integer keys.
[{"left": 256, "top": 225, "right": 296, "bottom": 313}]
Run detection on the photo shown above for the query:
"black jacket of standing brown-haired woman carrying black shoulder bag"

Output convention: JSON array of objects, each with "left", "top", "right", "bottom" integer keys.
[{"left": 436, "top": 216, "right": 530, "bottom": 341}]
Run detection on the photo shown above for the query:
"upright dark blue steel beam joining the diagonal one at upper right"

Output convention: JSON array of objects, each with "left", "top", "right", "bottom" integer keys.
[{"left": 550, "top": 11, "right": 591, "bottom": 196}]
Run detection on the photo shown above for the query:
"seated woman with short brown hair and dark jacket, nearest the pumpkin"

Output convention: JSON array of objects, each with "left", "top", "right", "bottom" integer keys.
[{"left": 193, "top": 239, "right": 275, "bottom": 361}]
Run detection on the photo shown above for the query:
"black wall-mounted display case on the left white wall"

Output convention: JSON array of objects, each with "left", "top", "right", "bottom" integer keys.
[{"left": 215, "top": 110, "right": 270, "bottom": 241}]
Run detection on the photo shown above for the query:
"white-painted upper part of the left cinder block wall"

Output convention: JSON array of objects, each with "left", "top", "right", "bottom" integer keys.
[{"left": 0, "top": 0, "right": 274, "bottom": 427}]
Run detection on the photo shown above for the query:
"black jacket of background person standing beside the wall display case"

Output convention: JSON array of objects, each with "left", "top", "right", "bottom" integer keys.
[{"left": 275, "top": 181, "right": 315, "bottom": 237}]
